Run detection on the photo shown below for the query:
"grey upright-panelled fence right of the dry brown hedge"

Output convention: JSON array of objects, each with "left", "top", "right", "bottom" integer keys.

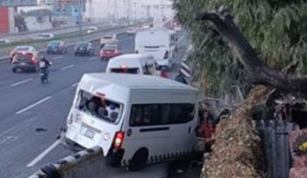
[{"left": 256, "top": 120, "right": 299, "bottom": 178}]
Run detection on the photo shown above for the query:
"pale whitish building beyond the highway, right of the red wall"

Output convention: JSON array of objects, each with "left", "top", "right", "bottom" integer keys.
[{"left": 25, "top": 9, "right": 52, "bottom": 31}]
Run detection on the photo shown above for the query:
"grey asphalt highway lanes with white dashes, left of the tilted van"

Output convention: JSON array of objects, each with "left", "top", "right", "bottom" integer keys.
[{"left": 0, "top": 30, "right": 185, "bottom": 178}]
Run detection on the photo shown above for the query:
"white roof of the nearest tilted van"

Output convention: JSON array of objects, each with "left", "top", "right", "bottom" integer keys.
[{"left": 81, "top": 73, "right": 196, "bottom": 91}]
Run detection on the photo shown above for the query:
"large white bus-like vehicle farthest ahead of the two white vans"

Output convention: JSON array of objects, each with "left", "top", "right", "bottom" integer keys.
[{"left": 135, "top": 28, "right": 177, "bottom": 67}]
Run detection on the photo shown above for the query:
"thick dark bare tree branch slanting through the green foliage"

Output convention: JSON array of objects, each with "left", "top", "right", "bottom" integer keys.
[{"left": 196, "top": 7, "right": 307, "bottom": 92}]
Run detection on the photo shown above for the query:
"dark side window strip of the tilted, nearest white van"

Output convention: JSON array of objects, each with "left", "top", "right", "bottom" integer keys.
[{"left": 130, "top": 104, "right": 194, "bottom": 126}]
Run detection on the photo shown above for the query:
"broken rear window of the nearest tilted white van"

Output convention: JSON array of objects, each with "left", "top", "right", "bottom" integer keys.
[{"left": 77, "top": 90, "right": 123, "bottom": 123}]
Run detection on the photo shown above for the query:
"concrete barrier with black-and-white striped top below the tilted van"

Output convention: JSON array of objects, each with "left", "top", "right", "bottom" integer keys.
[{"left": 28, "top": 146, "right": 167, "bottom": 178}]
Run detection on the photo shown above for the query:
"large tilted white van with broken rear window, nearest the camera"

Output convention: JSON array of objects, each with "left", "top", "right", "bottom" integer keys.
[{"left": 64, "top": 73, "right": 198, "bottom": 170}]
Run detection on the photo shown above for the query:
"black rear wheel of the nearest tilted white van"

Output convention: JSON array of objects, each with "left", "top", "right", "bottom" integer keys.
[{"left": 128, "top": 148, "right": 148, "bottom": 171}]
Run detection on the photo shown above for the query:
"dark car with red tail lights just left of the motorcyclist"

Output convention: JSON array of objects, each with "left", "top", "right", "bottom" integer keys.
[{"left": 12, "top": 53, "right": 38, "bottom": 73}]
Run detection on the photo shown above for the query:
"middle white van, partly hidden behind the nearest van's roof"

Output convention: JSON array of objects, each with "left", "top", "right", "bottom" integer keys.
[{"left": 106, "top": 54, "right": 157, "bottom": 75}]
